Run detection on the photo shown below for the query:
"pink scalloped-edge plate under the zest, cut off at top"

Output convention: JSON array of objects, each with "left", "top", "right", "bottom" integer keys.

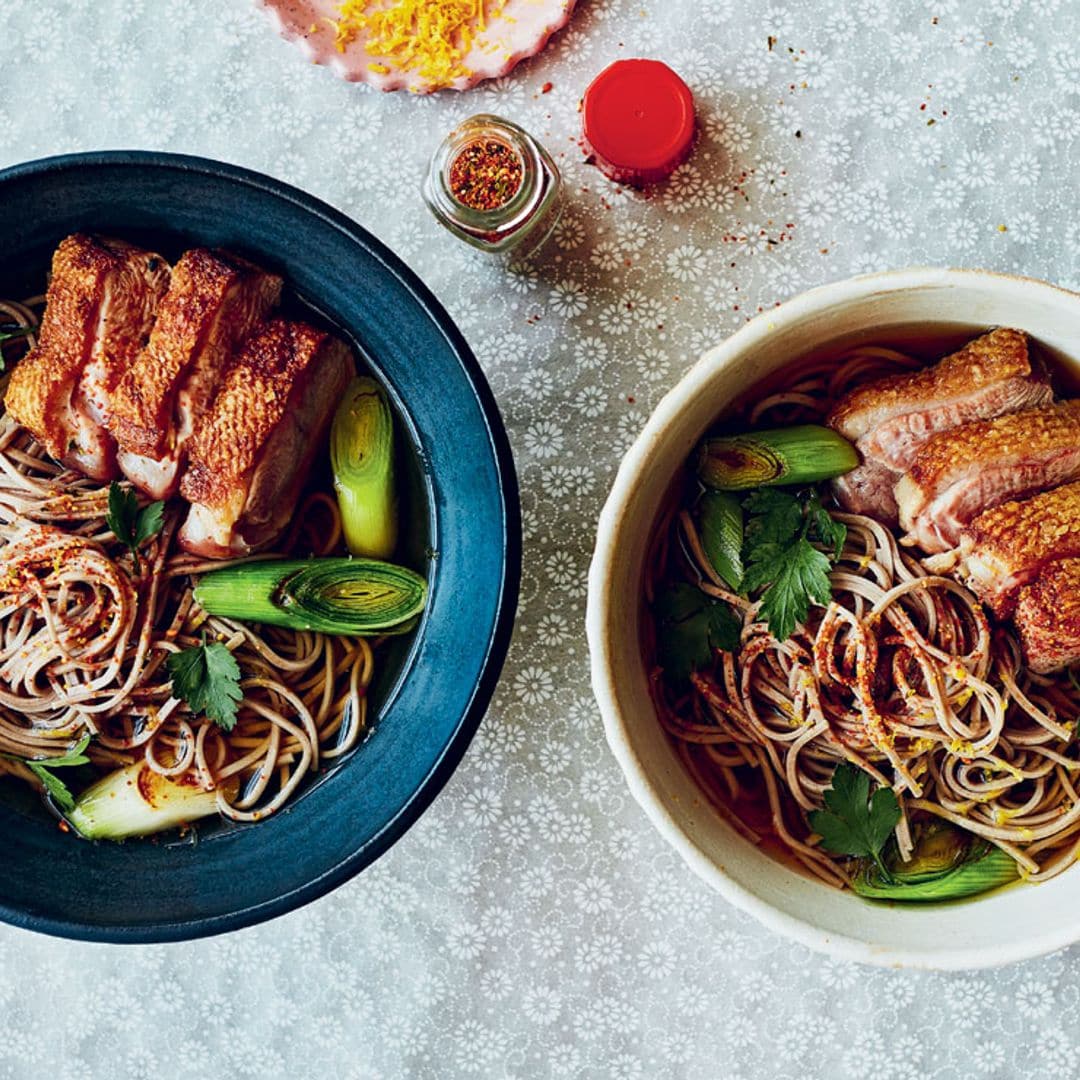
[{"left": 256, "top": 0, "right": 577, "bottom": 94}]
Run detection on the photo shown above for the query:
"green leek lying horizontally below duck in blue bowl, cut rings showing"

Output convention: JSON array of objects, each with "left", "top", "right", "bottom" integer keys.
[{"left": 194, "top": 558, "right": 428, "bottom": 637}]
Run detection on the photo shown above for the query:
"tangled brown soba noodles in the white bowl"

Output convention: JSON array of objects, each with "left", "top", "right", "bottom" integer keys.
[{"left": 646, "top": 348, "right": 1080, "bottom": 887}]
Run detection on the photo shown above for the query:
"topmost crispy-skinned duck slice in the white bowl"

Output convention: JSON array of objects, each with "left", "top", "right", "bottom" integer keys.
[{"left": 827, "top": 328, "right": 1053, "bottom": 526}]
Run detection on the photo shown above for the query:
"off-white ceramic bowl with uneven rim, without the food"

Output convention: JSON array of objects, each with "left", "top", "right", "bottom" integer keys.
[{"left": 588, "top": 269, "right": 1080, "bottom": 969}]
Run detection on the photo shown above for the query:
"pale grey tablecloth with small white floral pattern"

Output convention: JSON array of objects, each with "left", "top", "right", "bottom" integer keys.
[{"left": 0, "top": 0, "right": 1080, "bottom": 1080}]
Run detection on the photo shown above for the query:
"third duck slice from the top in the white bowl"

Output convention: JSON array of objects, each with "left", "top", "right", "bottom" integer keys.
[{"left": 958, "top": 483, "right": 1080, "bottom": 619}]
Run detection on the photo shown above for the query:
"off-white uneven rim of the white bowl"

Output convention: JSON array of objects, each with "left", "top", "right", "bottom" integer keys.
[{"left": 585, "top": 267, "right": 1080, "bottom": 971}]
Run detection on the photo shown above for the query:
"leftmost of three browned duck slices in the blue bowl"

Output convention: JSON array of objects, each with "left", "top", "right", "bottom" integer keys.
[{"left": 4, "top": 233, "right": 170, "bottom": 481}]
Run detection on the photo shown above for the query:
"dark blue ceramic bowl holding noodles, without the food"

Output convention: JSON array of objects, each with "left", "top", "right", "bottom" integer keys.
[{"left": 0, "top": 151, "right": 521, "bottom": 942}]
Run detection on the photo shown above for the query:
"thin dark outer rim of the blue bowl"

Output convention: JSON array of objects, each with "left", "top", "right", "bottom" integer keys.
[{"left": 0, "top": 149, "right": 522, "bottom": 944}]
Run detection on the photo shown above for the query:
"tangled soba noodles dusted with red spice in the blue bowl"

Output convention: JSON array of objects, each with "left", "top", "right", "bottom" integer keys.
[{"left": 0, "top": 297, "right": 374, "bottom": 821}]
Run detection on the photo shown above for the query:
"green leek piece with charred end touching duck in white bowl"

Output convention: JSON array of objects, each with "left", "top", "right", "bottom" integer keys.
[{"left": 698, "top": 423, "right": 859, "bottom": 491}]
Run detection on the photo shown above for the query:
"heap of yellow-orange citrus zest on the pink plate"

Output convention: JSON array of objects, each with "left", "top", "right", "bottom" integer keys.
[{"left": 334, "top": 0, "right": 507, "bottom": 87}]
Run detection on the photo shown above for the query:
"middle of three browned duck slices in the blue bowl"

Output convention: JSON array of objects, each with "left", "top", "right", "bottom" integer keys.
[{"left": 108, "top": 248, "right": 282, "bottom": 499}]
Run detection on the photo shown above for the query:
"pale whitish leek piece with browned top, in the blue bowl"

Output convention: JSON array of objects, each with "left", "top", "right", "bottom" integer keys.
[{"left": 67, "top": 761, "right": 239, "bottom": 840}]
